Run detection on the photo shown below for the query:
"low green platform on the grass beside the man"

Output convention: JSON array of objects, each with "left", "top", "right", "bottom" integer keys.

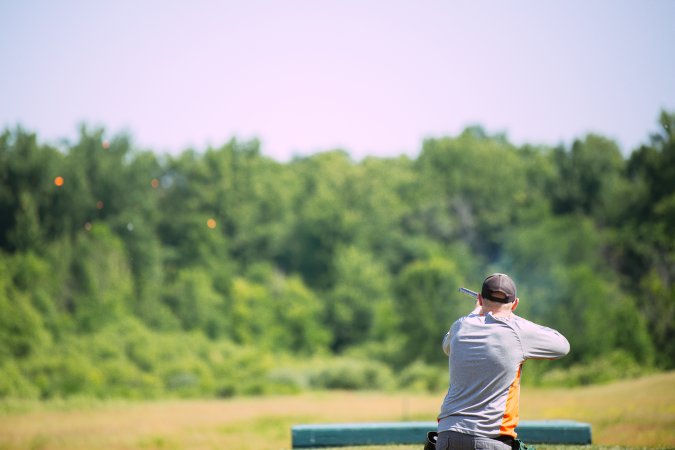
[{"left": 291, "top": 420, "right": 591, "bottom": 448}]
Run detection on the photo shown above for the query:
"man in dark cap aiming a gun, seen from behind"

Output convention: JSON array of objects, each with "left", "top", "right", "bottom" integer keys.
[{"left": 436, "top": 273, "right": 570, "bottom": 450}]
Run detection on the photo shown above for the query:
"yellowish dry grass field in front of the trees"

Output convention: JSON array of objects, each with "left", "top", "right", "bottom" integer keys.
[{"left": 0, "top": 372, "right": 675, "bottom": 450}]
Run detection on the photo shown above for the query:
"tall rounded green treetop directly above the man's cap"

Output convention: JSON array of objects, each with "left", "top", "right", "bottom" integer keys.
[{"left": 415, "top": 128, "right": 528, "bottom": 259}]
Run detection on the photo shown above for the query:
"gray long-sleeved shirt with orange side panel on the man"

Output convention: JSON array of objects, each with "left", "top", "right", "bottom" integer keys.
[{"left": 438, "top": 313, "right": 570, "bottom": 438}]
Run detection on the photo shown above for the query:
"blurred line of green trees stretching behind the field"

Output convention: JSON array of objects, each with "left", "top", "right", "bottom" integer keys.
[{"left": 0, "top": 111, "right": 675, "bottom": 398}]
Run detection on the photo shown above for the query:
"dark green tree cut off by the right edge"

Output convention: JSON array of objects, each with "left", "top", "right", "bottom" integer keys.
[{"left": 616, "top": 111, "right": 675, "bottom": 368}]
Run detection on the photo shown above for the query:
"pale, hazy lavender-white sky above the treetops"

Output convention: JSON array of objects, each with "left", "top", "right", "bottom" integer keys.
[{"left": 0, "top": 0, "right": 675, "bottom": 161}]
